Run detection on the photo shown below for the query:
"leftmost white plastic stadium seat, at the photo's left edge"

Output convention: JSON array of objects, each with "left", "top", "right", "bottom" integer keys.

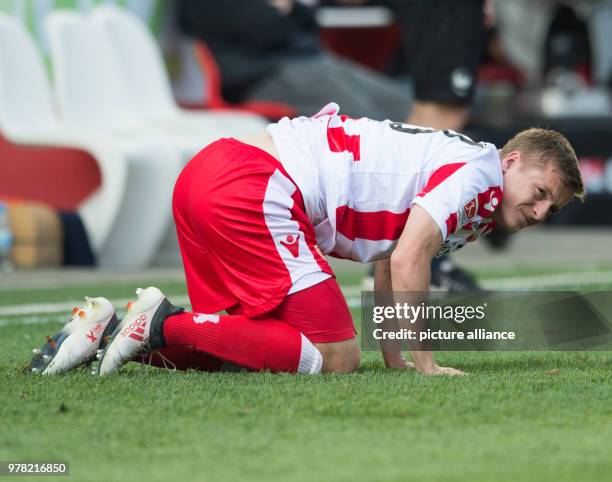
[{"left": 0, "top": 14, "right": 172, "bottom": 268}]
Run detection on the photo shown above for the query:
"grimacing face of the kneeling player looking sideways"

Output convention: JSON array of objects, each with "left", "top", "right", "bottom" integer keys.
[{"left": 493, "top": 151, "right": 573, "bottom": 232}]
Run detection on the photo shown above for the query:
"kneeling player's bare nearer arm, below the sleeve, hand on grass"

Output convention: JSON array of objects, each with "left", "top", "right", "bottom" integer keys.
[{"left": 390, "top": 204, "right": 462, "bottom": 375}]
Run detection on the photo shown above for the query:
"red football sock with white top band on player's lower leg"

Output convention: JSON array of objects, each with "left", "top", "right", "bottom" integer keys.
[{"left": 164, "top": 312, "right": 322, "bottom": 373}]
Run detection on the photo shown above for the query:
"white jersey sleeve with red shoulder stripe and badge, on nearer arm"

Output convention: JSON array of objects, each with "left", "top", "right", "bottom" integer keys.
[{"left": 412, "top": 158, "right": 501, "bottom": 242}]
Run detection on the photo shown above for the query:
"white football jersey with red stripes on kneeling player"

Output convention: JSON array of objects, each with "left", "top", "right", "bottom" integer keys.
[{"left": 268, "top": 103, "right": 503, "bottom": 262}]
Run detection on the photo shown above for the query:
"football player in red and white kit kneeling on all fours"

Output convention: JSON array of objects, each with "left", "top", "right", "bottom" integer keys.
[{"left": 32, "top": 103, "right": 583, "bottom": 375}]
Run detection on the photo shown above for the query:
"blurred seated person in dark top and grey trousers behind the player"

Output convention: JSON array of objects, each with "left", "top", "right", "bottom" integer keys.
[{"left": 177, "top": 0, "right": 411, "bottom": 120}]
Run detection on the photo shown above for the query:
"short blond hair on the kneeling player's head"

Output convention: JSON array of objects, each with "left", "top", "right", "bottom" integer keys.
[{"left": 501, "top": 127, "right": 585, "bottom": 200}]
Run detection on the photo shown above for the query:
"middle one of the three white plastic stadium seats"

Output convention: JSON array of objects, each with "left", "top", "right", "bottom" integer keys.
[{"left": 45, "top": 10, "right": 190, "bottom": 264}]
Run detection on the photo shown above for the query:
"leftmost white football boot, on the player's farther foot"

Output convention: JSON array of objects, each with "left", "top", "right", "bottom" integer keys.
[{"left": 30, "top": 297, "right": 119, "bottom": 375}]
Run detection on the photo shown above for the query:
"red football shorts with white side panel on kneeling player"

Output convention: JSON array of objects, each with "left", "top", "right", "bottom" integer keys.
[{"left": 172, "top": 139, "right": 354, "bottom": 342}]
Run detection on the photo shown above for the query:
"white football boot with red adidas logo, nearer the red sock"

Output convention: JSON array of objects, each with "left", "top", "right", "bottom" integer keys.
[{"left": 97, "top": 286, "right": 183, "bottom": 375}]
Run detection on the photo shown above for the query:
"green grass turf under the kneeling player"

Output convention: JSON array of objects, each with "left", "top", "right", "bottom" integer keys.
[{"left": 0, "top": 266, "right": 612, "bottom": 482}]
